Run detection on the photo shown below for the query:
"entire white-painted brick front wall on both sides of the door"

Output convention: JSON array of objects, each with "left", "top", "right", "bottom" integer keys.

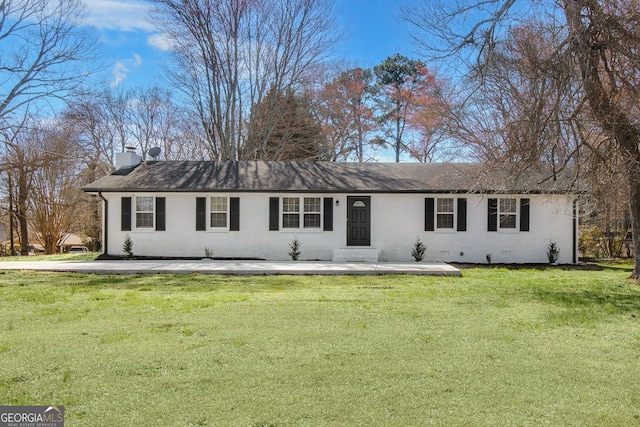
[{"left": 104, "top": 193, "right": 574, "bottom": 263}]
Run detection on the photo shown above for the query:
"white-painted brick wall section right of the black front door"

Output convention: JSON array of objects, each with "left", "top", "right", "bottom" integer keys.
[{"left": 371, "top": 195, "right": 574, "bottom": 263}]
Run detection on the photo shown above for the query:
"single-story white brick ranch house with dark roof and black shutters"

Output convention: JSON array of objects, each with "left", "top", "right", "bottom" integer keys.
[{"left": 84, "top": 153, "right": 578, "bottom": 263}]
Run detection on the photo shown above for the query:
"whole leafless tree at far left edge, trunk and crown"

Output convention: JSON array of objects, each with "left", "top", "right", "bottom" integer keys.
[{"left": 0, "top": 0, "right": 95, "bottom": 254}]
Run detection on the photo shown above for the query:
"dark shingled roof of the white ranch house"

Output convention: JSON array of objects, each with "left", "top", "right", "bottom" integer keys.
[{"left": 84, "top": 161, "right": 566, "bottom": 193}]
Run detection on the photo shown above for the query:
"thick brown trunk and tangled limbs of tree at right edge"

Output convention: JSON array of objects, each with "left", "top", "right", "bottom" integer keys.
[{"left": 563, "top": 0, "right": 640, "bottom": 279}]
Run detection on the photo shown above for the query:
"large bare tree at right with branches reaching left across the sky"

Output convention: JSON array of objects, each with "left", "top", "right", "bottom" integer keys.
[{"left": 405, "top": 0, "right": 640, "bottom": 279}]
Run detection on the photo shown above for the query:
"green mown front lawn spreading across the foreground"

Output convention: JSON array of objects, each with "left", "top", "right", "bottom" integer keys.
[{"left": 0, "top": 265, "right": 640, "bottom": 426}]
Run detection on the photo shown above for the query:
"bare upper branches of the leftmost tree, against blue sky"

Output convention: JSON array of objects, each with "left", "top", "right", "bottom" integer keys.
[{"left": 0, "top": 0, "right": 99, "bottom": 128}]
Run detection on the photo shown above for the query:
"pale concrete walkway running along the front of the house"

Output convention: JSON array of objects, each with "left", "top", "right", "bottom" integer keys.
[{"left": 0, "top": 260, "right": 461, "bottom": 276}]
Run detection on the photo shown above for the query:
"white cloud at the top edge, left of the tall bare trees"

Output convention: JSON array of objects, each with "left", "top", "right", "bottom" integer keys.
[{"left": 84, "top": 0, "right": 155, "bottom": 32}]
